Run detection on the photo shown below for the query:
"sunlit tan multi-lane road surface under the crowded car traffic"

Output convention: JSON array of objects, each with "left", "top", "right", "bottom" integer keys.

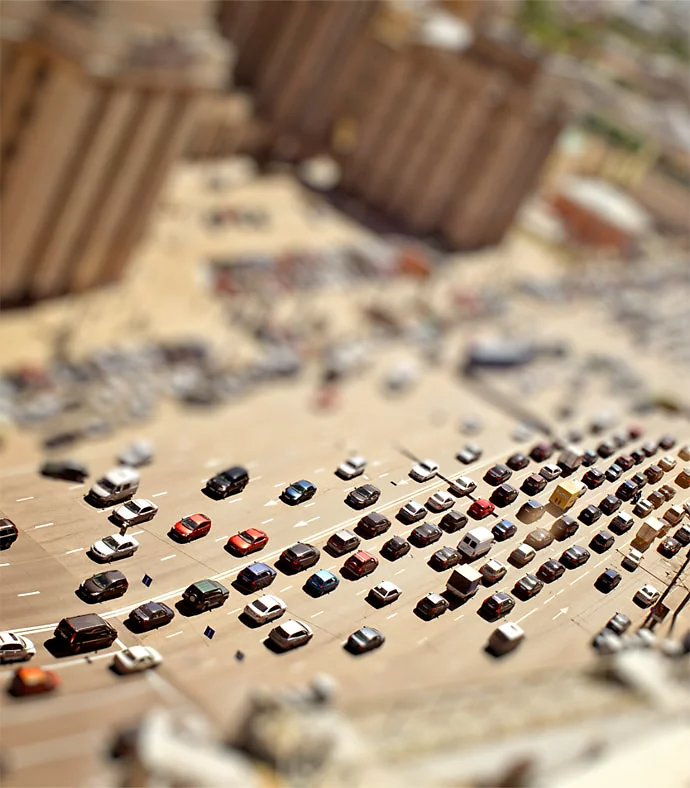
[{"left": 0, "top": 352, "right": 690, "bottom": 786}]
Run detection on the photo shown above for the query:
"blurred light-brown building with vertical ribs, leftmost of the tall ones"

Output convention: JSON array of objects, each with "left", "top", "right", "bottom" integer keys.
[{"left": 0, "top": 0, "right": 231, "bottom": 306}]
